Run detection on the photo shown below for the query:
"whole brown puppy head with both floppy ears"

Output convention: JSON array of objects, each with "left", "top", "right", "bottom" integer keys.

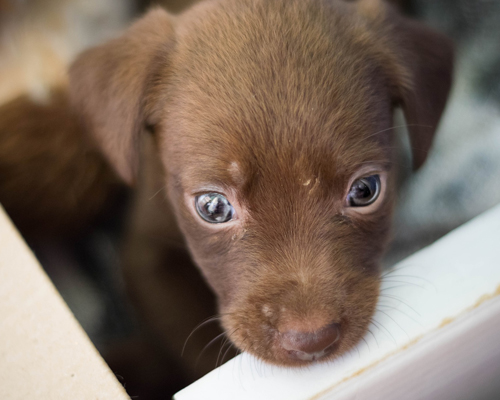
[{"left": 71, "top": 0, "right": 452, "bottom": 365}]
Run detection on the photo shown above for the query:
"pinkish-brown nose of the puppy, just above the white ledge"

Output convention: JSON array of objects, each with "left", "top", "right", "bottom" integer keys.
[{"left": 280, "top": 323, "right": 340, "bottom": 361}]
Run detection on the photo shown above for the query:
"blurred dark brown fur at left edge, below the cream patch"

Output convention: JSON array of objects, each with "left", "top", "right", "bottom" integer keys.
[{"left": 0, "top": 89, "right": 122, "bottom": 238}]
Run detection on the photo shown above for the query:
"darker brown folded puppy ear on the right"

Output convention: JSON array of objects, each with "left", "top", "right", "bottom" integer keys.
[{"left": 359, "top": 0, "right": 454, "bottom": 169}]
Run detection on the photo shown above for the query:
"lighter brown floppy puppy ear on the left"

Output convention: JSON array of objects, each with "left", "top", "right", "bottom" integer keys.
[{"left": 70, "top": 8, "right": 174, "bottom": 184}]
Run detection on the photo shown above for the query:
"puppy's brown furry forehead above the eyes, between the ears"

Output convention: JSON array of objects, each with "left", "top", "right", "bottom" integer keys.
[{"left": 169, "top": 0, "right": 391, "bottom": 187}]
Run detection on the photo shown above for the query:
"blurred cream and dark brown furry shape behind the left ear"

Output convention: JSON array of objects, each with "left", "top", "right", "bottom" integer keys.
[{"left": 0, "top": 0, "right": 132, "bottom": 234}]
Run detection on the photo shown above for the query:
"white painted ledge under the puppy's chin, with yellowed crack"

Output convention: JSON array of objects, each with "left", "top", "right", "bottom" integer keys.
[{"left": 175, "top": 206, "right": 500, "bottom": 400}]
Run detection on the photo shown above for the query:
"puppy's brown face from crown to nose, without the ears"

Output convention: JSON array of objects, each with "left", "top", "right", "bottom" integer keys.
[{"left": 157, "top": 3, "right": 393, "bottom": 365}]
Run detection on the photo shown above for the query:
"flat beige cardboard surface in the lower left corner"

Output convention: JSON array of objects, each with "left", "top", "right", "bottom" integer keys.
[{"left": 0, "top": 207, "right": 129, "bottom": 400}]
